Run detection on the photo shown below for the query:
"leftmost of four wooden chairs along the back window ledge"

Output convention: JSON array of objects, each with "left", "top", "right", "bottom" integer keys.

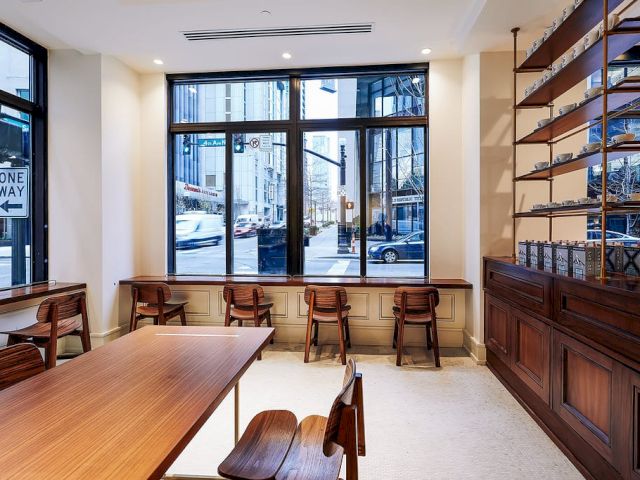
[{"left": 129, "top": 283, "right": 188, "bottom": 332}]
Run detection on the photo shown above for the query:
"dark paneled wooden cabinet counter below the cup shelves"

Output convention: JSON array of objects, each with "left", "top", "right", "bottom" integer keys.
[{"left": 484, "top": 257, "right": 640, "bottom": 480}]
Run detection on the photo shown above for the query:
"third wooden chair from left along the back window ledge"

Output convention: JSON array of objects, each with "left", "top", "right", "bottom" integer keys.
[{"left": 304, "top": 285, "right": 351, "bottom": 365}]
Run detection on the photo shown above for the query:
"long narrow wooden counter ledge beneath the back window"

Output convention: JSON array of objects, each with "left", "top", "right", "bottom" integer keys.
[{"left": 120, "top": 275, "right": 472, "bottom": 290}]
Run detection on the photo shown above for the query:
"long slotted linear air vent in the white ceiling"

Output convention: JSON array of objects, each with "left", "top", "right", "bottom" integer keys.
[{"left": 182, "top": 23, "right": 373, "bottom": 41}]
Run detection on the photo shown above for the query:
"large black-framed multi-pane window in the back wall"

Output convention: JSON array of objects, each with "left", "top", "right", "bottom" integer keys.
[{"left": 168, "top": 65, "right": 428, "bottom": 277}]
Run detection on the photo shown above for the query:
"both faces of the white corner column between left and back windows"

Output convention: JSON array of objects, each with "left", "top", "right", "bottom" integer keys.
[{"left": 49, "top": 50, "right": 142, "bottom": 345}]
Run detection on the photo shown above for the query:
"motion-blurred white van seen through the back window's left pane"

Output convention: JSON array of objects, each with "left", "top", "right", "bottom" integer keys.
[{"left": 176, "top": 212, "right": 224, "bottom": 249}]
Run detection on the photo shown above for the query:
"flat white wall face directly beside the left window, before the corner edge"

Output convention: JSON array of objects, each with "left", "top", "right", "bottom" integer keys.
[{"left": 48, "top": 50, "right": 103, "bottom": 331}]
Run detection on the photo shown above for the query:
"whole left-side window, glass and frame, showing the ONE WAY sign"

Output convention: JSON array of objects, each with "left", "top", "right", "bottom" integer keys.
[{"left": 0, "top": 24, "right": 47, "bottom": 288}]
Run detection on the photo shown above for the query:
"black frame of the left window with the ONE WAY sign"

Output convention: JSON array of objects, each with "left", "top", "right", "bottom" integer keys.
[{"left": 0, "top": 23, "right": 49, "bottom": 290}]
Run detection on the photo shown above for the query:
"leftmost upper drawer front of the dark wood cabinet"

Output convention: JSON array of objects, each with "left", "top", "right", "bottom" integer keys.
[{"left": 484, "top": 261, "right": 553, "bottom": 318}]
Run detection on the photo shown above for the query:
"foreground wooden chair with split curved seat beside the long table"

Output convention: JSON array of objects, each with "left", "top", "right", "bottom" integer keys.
[{"left": 218, "top": 360, "right": 366, "bottom": 480}]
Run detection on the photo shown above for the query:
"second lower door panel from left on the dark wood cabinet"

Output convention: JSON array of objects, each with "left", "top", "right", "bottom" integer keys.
[{"left": 511, "top": 309, "right": 551, "bottom": 405}]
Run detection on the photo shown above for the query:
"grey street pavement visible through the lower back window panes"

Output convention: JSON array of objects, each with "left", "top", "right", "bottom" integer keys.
[{"left": 176, "top": 225, "right": 424, "bottom": 277}]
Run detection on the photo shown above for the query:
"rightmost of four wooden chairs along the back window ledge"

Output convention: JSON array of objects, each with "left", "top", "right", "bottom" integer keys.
[{"left": 393, "top": 287, "right": 440, "bottom": 367}]
